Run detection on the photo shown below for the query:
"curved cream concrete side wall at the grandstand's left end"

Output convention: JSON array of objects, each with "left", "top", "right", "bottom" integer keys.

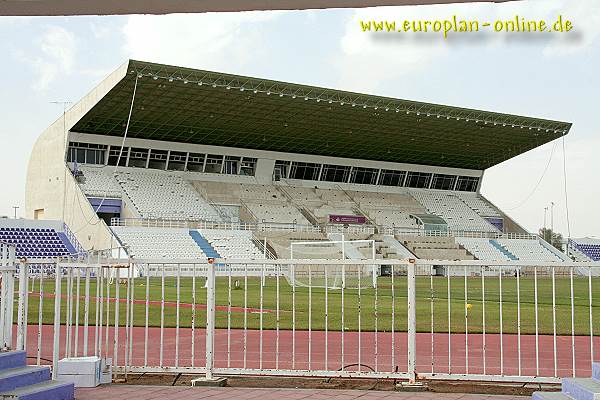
[{"left": 25, "top": 64, "right": 127, "bottom": 250}]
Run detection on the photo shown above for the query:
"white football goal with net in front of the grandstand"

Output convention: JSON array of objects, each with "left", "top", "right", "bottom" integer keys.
[{"left": 288, "top": 240, "right": 379, "bottom": 289}]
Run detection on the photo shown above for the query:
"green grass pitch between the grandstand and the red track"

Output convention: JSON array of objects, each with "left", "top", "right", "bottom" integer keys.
[{"left": 19, "top": 277, "right": 600, "bottom": 335}]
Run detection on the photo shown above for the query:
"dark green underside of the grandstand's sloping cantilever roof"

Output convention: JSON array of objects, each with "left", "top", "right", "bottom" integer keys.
[{"left": 71, "top": 61, "right": 571, "bottom": 169}]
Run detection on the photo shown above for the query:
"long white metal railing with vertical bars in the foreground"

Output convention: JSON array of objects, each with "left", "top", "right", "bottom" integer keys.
[{"left": 9, "top": 254, "right": 600, "bottom": 383}]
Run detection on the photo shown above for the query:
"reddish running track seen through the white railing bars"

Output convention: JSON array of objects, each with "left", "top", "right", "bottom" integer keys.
[{"left": 15, "top": 325, "right": 600, "bottom": 377}]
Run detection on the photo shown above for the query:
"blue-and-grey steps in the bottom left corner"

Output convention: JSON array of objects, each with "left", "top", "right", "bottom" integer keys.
[{"left": 0, "top": 351, "right": 75, "bottom": 400}]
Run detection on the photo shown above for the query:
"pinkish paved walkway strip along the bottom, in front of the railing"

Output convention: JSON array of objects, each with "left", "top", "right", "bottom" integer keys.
[{"left": 75, "top": 385, "right": 530, "bottom": 400}]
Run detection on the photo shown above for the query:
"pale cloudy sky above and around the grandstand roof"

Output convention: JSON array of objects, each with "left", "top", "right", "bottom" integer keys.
[{"left": 0, "top": 0, "right": 600, "bottom": 237}]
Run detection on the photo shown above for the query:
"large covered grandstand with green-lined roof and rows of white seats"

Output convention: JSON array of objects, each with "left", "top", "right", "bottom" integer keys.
[{"left": 26, "top": 61, "right": 573, "bottom": 263}]
